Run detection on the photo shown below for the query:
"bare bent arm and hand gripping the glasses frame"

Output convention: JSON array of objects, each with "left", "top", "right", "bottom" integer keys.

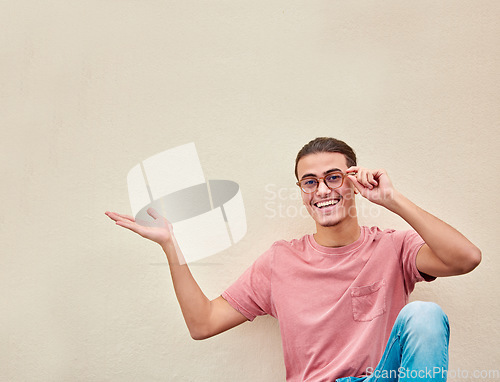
[{"left": 347, "top": 166, "right": 481, "bottom": 277}]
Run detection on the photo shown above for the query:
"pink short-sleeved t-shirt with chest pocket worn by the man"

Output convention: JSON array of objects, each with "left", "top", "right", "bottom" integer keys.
[{"left": 222, "top": 227, "right": 432, "bottom": 382}]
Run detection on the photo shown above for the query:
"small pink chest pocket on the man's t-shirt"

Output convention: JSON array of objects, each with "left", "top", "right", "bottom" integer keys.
[{"left": 351, "top": 280, "right": 386, "bottom": 321}]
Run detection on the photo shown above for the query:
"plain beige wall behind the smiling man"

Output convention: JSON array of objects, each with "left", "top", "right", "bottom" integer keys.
[{"left": 0, "top": 0, "right": 500, "bottom": 381}]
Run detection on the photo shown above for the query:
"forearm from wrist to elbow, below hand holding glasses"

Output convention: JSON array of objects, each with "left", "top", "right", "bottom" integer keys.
[{"left": 387, "top": 191, "right": 481, "bottom": 273}]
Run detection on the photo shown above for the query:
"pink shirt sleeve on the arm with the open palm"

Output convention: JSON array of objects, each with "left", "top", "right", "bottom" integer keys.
[{"left": 222, "top": 247, "right": 273, "bottom": 321}]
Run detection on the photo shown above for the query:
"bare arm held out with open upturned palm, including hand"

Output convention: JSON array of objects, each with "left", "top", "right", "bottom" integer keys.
[{"left": 106, "top": 208, "right": 247, "bottom": 340}]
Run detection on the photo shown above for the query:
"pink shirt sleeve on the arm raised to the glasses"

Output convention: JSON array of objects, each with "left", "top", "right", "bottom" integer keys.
[{"left": 393, "top": 230, "right": 436, "bottom": 293}]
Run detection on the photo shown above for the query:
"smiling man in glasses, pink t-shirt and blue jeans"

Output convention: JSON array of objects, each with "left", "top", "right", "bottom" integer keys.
[{"left": 107, "top": 138, "right": 481, "bottom": 381}]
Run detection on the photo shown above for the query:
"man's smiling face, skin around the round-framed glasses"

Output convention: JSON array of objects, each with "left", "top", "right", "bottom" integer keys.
[{"left": 297, "top": 152, "right": 357, "bottom": 227}]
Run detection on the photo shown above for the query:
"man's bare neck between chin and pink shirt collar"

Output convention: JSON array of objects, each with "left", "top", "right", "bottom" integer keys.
[{"left": 314, "top": 219, "right": 361, "bottom": 247}]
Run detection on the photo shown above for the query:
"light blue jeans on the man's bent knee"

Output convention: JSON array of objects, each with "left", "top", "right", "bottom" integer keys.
[{"left": 336, "top": 301, "right": 450, "bottom": 382}]
